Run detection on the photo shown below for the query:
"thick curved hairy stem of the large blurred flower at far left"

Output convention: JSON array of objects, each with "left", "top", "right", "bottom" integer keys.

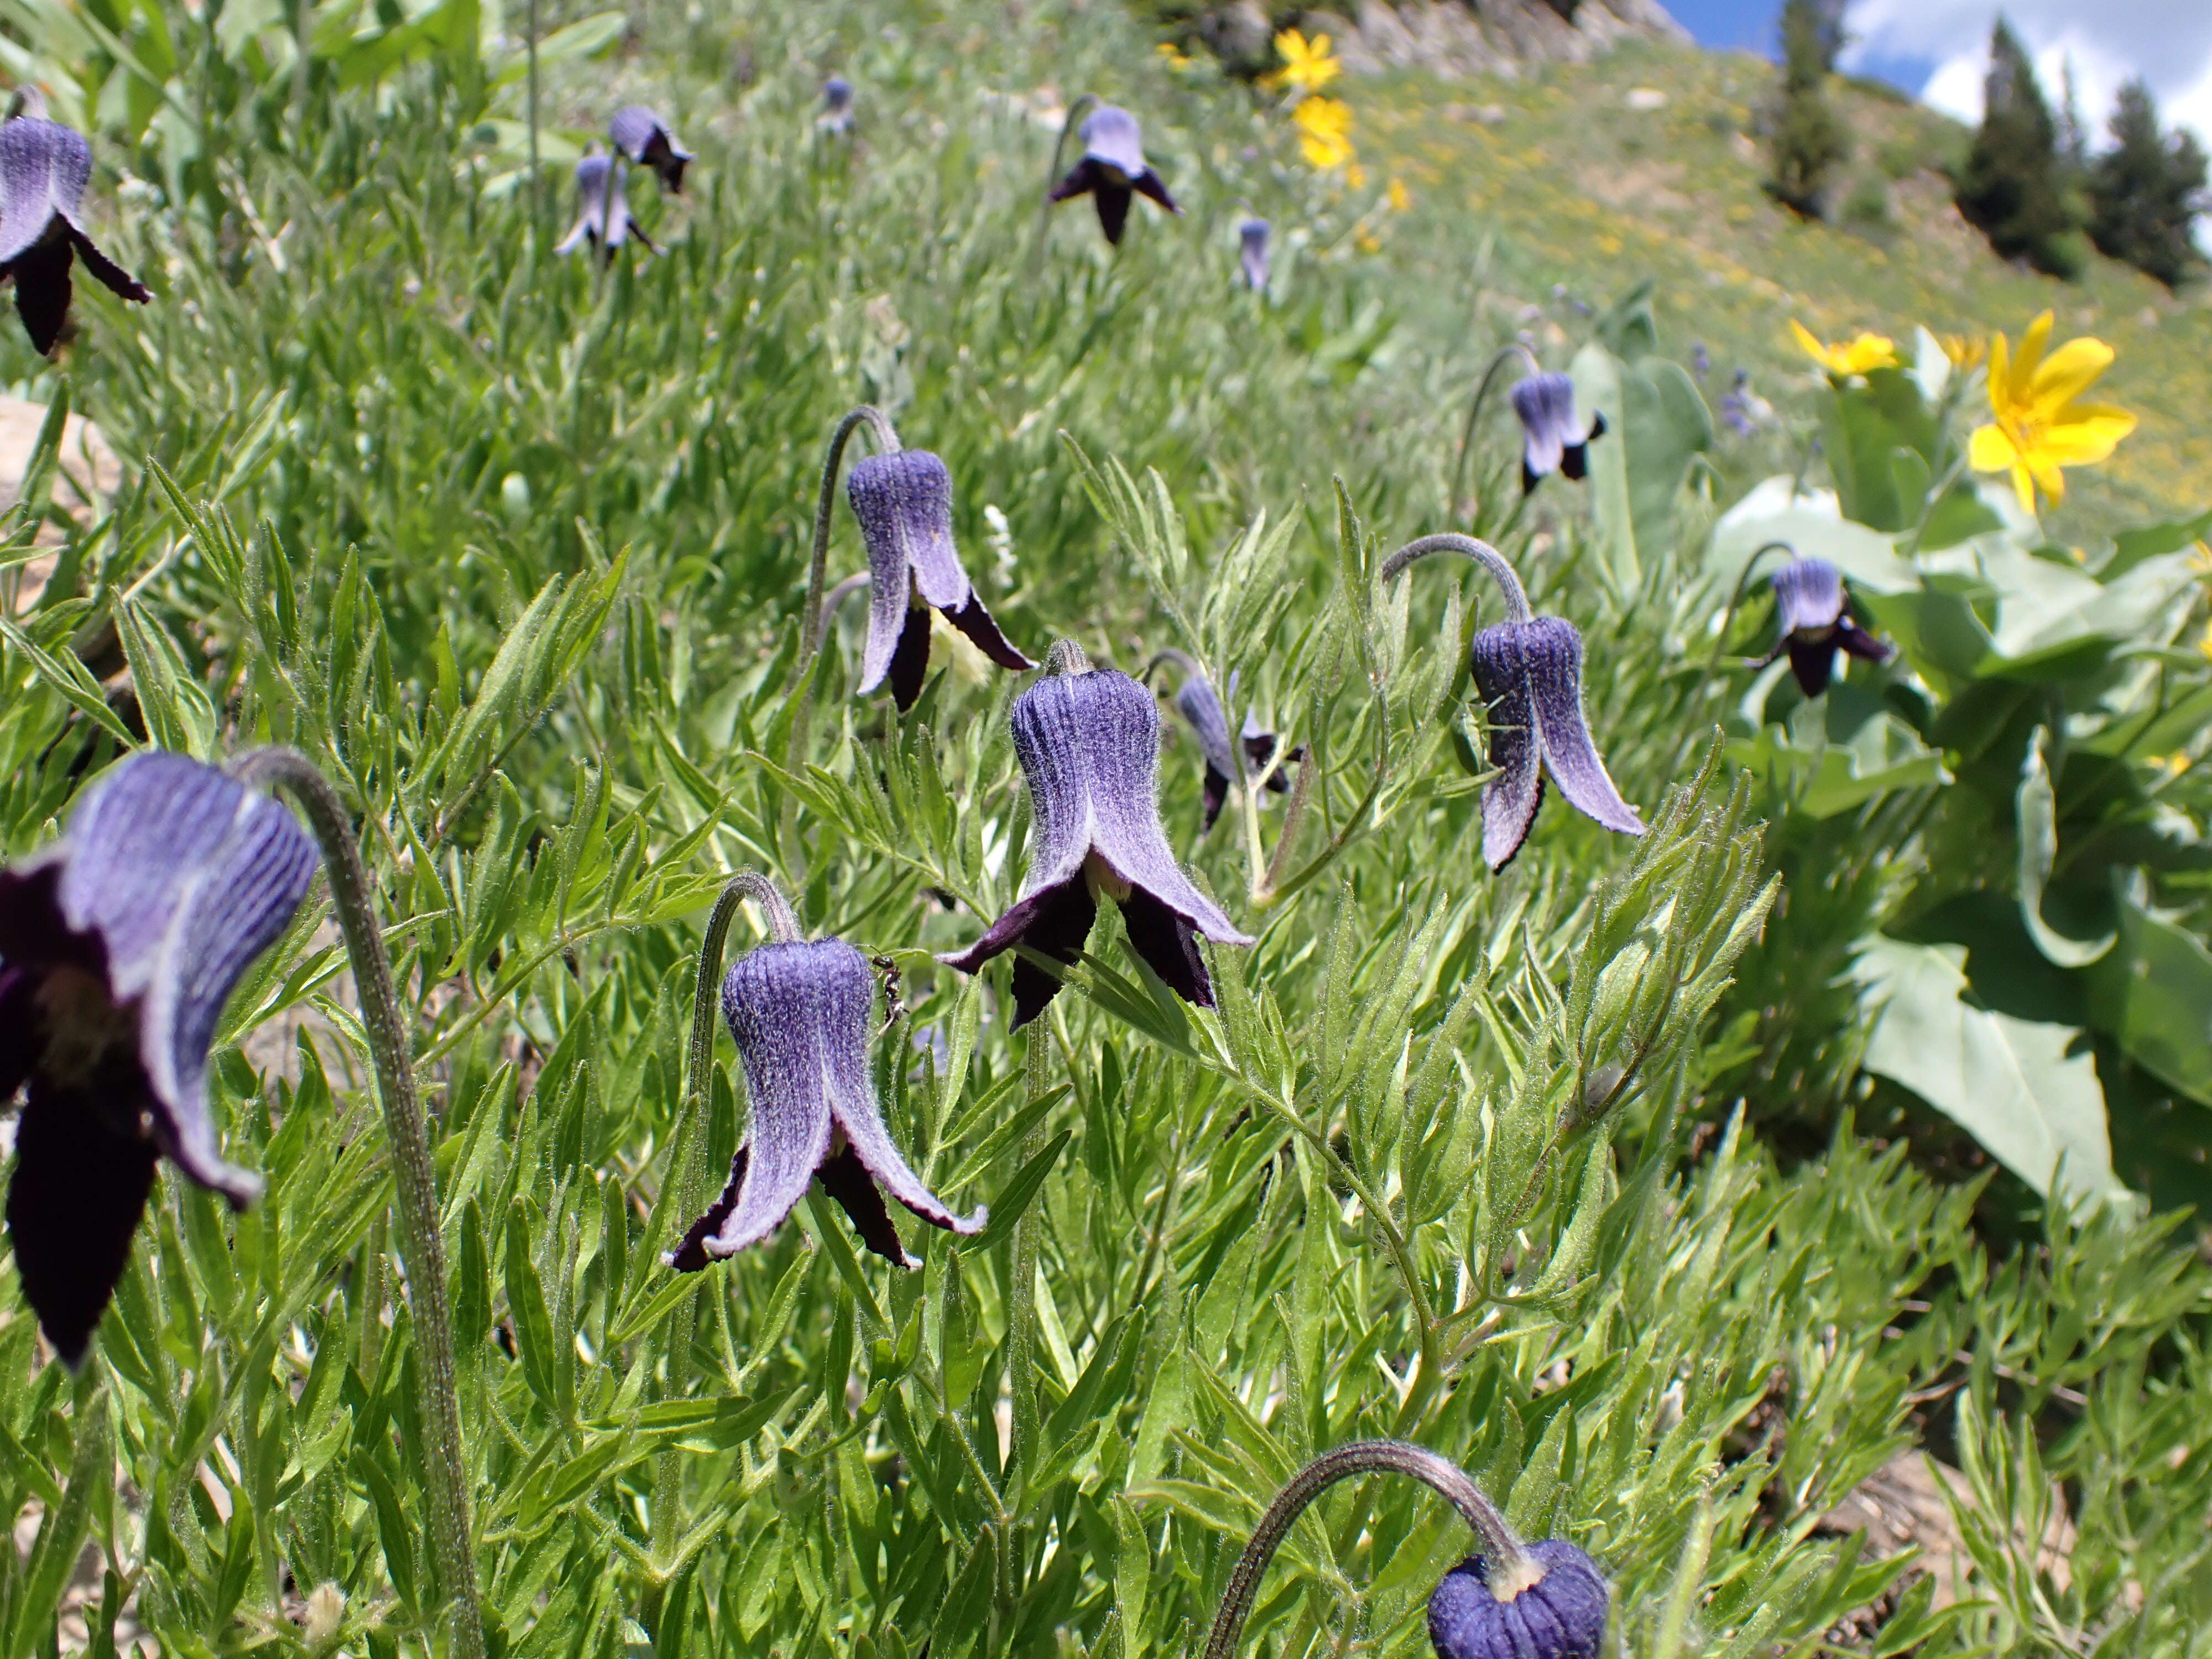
[{"left": 230, "top": 748, "right": 484, "bottom": 1659}]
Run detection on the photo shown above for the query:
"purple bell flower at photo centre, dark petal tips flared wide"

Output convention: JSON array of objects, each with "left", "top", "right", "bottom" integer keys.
[{"left": 938, "top": 646, "right": 1254, "bottom": 1026}]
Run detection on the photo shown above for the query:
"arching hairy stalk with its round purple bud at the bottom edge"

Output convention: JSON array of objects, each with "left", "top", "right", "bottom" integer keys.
[{"left": 1206, "top": 1440, "right": 1608, "bottom": 1659}]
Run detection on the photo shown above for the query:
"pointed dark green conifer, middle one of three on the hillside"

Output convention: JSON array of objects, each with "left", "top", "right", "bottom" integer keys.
[{"left": 1955, "top": 15, "right": 2088, "bottom": 279}]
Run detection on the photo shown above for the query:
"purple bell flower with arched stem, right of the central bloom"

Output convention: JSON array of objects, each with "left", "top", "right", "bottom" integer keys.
[{"left": 1383, "top": 535, "right": 1644, "bottom": 869}]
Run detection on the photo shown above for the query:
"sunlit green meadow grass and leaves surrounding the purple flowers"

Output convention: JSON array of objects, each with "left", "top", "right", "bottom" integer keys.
[{"left": 0, "top": 0, "right": 2212, "bottom": 1659}]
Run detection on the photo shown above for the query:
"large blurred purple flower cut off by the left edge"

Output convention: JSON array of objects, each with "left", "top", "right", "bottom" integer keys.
[{"left": 0, "top": 752, "right": 316, "bottom": 1367}]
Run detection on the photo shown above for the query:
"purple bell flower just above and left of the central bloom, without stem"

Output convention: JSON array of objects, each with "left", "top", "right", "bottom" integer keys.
[{"left": 845, "top": 449, "right": 1037, "bottom": 712}]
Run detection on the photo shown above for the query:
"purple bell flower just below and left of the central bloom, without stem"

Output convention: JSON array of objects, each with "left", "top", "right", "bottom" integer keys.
[{"left": 666, "top": 938, "right": 987, "bottom": 1272}]
